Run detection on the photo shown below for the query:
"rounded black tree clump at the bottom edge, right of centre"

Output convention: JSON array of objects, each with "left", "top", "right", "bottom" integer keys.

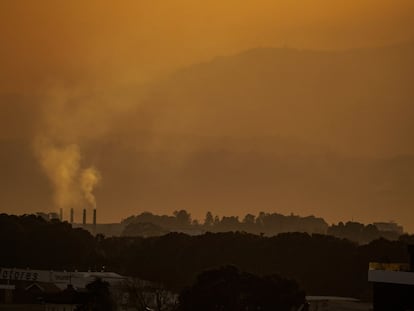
[{"left": 178, "top": 266, "right": 305, "bottom": 311}]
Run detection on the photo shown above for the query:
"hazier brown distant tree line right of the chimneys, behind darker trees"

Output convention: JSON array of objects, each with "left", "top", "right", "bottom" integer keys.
[{"left": 122, "top": 210, "right": 401, "bottom": 244}]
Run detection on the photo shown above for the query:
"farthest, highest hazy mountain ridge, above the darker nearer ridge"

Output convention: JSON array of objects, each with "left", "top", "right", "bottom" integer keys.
[{"left": 140, "top": 42, "right": 414, "bottom": 156}]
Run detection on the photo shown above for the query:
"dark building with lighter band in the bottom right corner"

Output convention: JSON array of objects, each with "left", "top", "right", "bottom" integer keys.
[{"left": 368, "top": 245, "right": 414, "bottom": 311}]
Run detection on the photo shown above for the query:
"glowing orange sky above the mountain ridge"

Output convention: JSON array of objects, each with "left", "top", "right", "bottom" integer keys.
[{"left": 0, "top": 0, "right": 414, "bottom": 90}]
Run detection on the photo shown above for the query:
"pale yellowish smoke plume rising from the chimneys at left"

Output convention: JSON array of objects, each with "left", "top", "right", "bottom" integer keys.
[{"left": 29, "top": 84, "right": 109, "bottom": 213}]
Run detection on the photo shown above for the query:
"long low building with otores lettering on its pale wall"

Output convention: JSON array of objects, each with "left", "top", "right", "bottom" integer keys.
[{"left": 0, "top": 268, "right": 126, "bottom": 311}]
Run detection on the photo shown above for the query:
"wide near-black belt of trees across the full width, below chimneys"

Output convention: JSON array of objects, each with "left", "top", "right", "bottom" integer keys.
[{"left": 0, "top": 214, "right": 414, "bottom": 297}]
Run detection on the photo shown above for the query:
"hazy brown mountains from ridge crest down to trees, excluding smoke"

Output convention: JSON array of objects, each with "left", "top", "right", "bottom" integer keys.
[{"left": 0, "top": 43, "right": 414, "bottom": 232}]
